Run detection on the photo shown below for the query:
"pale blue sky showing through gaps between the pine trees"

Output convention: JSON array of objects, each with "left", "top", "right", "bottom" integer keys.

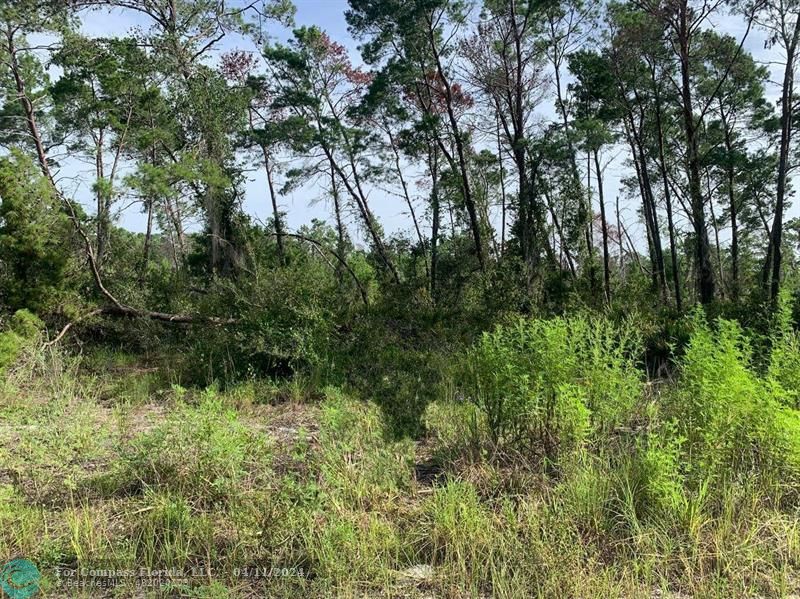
[{"left": 62, "top": 0, "right": 798, "bottom": 252}]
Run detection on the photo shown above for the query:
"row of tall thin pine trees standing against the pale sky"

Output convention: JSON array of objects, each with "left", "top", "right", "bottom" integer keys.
[{"left": 0, "top": 0, "right": 800, "bottom": 324}]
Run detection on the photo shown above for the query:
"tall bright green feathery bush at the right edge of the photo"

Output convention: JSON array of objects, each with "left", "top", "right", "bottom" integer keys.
[{"left": 668, "top": 310, "right": 800, "bottom": 496}]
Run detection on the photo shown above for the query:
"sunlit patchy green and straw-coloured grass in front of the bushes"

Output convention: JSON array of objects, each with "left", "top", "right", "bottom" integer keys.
[{"left": 0, "top": 325, "right": 800, "bottom": 598}]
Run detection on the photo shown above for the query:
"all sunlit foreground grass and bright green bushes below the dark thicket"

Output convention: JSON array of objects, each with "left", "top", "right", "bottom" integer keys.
[{"left": 0, "top": 312, "right": 800, "bottom": 597}]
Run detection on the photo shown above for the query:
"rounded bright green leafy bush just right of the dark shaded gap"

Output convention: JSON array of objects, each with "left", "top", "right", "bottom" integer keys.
[{"left": 463, "top": 317, "right": 641, "bottom": 460}]
